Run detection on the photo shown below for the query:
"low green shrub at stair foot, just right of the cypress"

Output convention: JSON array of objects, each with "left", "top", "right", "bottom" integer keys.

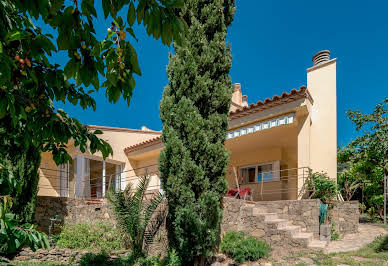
[{"left": 221, "top": 231, "right": 270, "bottom": 263}]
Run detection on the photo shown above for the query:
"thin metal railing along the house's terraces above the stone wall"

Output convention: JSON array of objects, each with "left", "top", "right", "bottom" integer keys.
[{"left": 39, "top": 164, "right": 311, "bottom": 201}]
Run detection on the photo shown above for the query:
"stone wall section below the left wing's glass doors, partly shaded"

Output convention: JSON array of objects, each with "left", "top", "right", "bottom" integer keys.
[{"left": 35, "top": 196, "right": 114, "bottom": 233}]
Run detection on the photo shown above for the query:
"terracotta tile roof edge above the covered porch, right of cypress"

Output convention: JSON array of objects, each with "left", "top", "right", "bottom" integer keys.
[{"left": 229, "top": 86, "right": 313, "bottom": 120}]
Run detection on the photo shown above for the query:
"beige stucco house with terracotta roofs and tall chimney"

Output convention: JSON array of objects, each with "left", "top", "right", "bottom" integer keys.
[{"left": 39, "top": 50, "right": 337, "bottom": 200}]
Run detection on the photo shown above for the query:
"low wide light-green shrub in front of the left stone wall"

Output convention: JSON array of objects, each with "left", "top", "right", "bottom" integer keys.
[{"left": 56, "top": 222, "right": 125, "bottom": 252}]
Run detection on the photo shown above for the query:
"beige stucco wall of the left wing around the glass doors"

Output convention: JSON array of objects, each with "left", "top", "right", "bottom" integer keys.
[{"left": 38, "top": 129, "right": 160, "bottom": 196}]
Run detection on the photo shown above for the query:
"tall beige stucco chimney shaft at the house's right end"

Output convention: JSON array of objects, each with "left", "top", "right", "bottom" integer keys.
[{"left": 307, "top": 59, "right": 337, "bottom": 180}]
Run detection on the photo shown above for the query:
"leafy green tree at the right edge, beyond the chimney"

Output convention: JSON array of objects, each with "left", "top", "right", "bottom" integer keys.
[{"left": 338, "top": 98, "right": 388, "bottom": 219}]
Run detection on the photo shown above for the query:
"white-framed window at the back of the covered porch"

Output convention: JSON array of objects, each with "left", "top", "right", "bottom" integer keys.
[{"left": 240, "top": 161, "right": 280, "bottom": 184}]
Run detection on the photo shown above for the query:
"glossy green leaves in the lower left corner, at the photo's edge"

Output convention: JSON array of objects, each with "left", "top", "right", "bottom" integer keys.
[{"left": 0, "top": 163, "right": 50, "bottom": 254}]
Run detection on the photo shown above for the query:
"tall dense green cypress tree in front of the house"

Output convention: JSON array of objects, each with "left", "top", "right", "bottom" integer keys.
[{"left": 159, "top": 0, "right": 235, "bottom": 264}]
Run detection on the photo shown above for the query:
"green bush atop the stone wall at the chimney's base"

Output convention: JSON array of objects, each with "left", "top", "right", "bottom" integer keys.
[{"left": 307, "top": 173, "right": 338, "bottom": 204}]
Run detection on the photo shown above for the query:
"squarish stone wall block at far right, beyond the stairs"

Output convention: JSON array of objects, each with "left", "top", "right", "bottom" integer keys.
[{"left": 328, "top": 200, "right": 360, "bottom": 235}]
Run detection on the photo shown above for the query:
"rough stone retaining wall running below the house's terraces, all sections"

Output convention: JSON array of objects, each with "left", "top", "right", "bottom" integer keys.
[{"left": 35, "top": 196, "right": 359, "bottom": 236}]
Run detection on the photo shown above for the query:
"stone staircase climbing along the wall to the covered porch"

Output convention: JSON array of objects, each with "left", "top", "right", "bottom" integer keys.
[{"left": 239, "top": 204, "right": 327, "bottom": 249}]
